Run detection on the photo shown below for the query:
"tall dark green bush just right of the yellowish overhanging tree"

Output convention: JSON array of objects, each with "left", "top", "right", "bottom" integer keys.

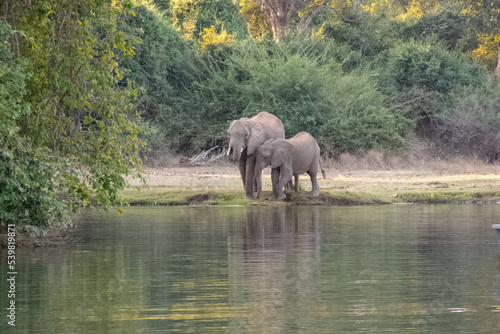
[{"left": 121, "top": 6, "right": 197, "bottom": 155}]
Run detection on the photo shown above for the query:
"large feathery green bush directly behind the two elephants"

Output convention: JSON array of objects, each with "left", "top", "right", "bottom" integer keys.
[{"left": 158, "top": 38, "right": 408, "bottom": 155}]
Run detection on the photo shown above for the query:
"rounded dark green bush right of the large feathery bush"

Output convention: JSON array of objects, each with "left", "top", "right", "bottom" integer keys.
[{"left": 372, "top": 39, "right": 488, "bottom": 136}]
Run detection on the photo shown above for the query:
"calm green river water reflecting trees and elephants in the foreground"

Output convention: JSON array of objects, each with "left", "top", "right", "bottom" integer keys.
[{"left": 0, "top": 205, "right": 500, "bottom": 334}]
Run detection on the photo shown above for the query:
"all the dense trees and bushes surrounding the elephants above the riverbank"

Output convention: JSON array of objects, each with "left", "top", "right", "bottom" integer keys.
[{"left": 0, "top": 0, "right": 500, "bottom": 231}]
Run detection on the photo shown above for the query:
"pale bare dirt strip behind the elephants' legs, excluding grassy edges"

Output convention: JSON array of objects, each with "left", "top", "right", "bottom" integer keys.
[{"left": 129, "top": 167, "right": 500, "bottom": 191}]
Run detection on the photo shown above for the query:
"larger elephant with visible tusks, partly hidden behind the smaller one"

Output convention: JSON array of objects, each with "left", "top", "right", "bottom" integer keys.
[{"left": 227, "top": 111, "right": 285, "bottom": 199}]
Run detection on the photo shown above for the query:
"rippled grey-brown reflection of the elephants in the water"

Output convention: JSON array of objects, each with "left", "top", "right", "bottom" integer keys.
[{"left": 229, "top": 206, "right": 320, "bottom": 333}]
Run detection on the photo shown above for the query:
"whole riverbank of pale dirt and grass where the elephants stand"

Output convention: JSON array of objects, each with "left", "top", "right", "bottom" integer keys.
[{"left": 122, "top": 160, "right": 500, "bottom": 205}]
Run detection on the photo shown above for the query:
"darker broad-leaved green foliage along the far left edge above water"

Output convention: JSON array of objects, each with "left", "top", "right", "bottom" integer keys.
[{"left": 0, "top": 22, "right": 66, "bottom": 232}]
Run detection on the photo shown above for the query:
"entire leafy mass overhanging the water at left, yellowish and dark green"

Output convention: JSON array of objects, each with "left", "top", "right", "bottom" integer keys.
[{"left": 0, "top": 0, "right": 147, "bottom": 228}]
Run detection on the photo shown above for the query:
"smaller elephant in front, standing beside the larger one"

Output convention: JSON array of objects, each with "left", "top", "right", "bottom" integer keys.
[{"left": 255, "top": 132, "right": 326, "bottom": 200}]
